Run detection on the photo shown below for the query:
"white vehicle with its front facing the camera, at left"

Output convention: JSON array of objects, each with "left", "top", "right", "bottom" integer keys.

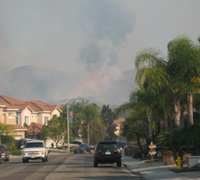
[{"left": 22, "top": 140, "right": 48, "bottom": 163}]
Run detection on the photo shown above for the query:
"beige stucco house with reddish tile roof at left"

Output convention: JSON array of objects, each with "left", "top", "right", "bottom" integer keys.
[{"left": 0, "top": 95, "right": 62, "bottom": 139}]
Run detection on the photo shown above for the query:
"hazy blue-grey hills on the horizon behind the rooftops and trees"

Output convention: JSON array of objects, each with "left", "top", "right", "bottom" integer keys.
[{"left": 0, "top": 66, "right": 137, "bottom": 106}]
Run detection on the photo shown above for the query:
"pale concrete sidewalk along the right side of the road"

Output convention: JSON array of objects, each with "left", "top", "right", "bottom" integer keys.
[{"left": 122, "top": 155, "right": 200, "bottom": 180}]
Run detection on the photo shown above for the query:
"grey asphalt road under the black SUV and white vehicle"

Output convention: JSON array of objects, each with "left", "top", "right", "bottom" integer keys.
[{"left": 0, "top": 153, "right": 138, "bottom": 180}]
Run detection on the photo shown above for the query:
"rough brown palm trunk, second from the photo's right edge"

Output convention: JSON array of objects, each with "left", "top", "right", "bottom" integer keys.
[{"left": 172, "top": 90, "right": 181, "bottom": 126}]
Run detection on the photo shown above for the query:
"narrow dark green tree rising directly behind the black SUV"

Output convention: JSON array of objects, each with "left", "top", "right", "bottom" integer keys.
[{"left": 100, "top": 105, "right": 116, "bottom": 140}]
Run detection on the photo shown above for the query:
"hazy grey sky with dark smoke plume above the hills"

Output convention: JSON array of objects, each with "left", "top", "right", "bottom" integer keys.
[{"left": 0, "top": 0, "right": 200, "bottom": 103}]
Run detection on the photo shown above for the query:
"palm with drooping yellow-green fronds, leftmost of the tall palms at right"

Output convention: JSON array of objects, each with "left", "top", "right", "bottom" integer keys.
[{"left": 135, "top": 48, "right": 170, "bottom": 140}]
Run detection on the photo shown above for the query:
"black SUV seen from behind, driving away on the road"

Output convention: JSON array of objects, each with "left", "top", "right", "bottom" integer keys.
[{"left": 94, "top": 141, "right": 122, "bottom": 167}]
